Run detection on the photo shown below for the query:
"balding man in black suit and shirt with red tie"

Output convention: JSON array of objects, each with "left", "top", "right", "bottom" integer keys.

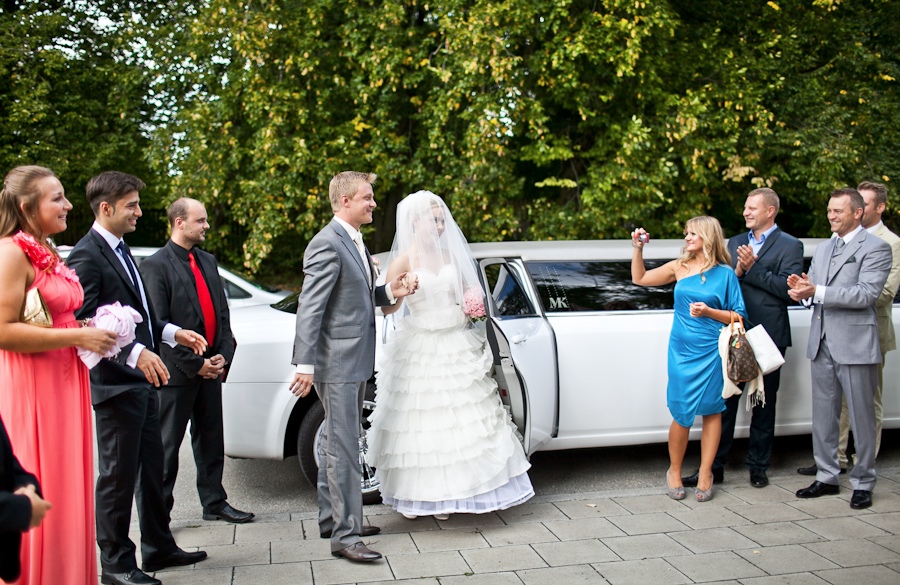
[{"left": 141, "top": 198, "right": 253, "bottom": 523}]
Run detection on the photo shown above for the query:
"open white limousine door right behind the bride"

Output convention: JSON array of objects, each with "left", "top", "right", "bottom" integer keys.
[{"left": 479, "top": 258, "right": 559, "bottom": 455}]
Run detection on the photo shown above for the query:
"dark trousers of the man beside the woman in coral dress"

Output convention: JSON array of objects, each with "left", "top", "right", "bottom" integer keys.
[{"left": 94, "top": 386, "right": 177, "bottom": 573}]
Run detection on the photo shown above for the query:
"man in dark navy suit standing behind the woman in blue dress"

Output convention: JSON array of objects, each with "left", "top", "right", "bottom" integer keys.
[{"left": 683, "top": 188, "right": 803, "bottom": 488}]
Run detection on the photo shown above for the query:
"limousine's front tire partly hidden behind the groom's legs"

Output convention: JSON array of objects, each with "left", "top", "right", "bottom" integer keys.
[{"left": 297, "top": 383, "right": 381, "bottom": 505}]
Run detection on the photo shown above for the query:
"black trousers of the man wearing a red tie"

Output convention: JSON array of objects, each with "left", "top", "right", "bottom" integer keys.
[{"left": 158, "top": 378, "right": 228, "bottom": 512}]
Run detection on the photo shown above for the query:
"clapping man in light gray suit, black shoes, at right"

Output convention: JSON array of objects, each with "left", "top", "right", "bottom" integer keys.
[{"left": 788, "top": 187, "right": 891, "bottom": 509}]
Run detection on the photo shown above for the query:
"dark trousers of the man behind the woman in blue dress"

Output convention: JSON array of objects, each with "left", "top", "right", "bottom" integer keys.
[{"left": 713, "top": 347, "right": 787, "bottom": 471}]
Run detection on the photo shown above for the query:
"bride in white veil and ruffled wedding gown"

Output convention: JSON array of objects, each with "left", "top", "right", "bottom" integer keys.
[{"left": 367, "top": 191, "right": 534, "bottom": 520}]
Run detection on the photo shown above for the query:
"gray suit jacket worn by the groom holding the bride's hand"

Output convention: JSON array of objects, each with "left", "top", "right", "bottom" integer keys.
[{"left": 292, "top": 221, "right": 389, "bottom": 383}]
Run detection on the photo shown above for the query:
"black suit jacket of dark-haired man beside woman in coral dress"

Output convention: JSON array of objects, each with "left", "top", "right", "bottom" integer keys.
[{"left": 67, "top": 229, "right": 167, "bottom": 405}]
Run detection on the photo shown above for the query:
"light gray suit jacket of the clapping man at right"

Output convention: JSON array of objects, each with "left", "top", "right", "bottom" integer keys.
[{"left": 806, "top": 230, "right": 891, "bottom": 364}]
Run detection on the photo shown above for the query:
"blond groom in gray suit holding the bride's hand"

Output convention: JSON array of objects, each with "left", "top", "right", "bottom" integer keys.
[{"left": 290, "top": 171, "right": 418, "bottom": 562}]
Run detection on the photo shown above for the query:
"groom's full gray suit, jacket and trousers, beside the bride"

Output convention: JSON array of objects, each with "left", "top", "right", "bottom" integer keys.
[{"left": 292, "top": 220, "right": 390, "bottom": 552}]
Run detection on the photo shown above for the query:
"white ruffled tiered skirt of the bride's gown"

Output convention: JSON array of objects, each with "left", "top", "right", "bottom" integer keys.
[{"left": 367, "top": 320, "right": 534, "bottom": 516}]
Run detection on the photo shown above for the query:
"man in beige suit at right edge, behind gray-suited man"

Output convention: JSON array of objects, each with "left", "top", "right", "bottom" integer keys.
[{"left": 838, "top": 181, "right": 900, "bottom": 469}]
